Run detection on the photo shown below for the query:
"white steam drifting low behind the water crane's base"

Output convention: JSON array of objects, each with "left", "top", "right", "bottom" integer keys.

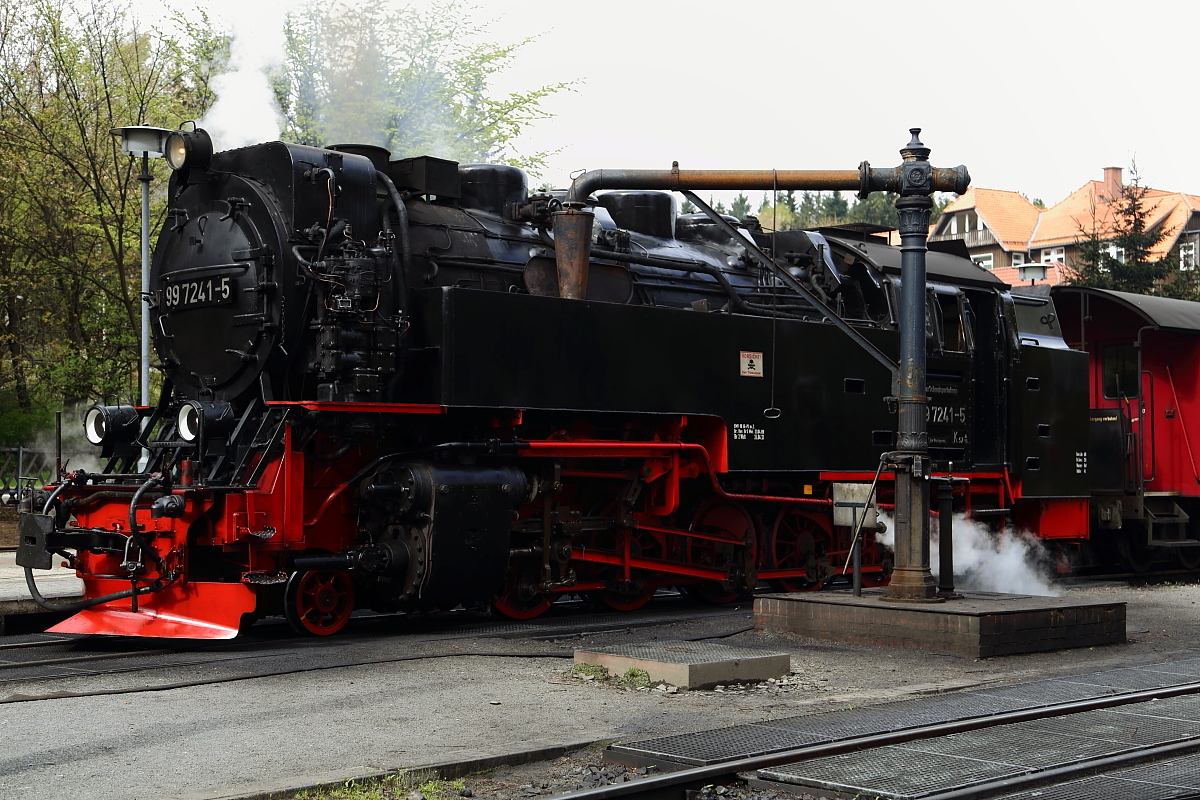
[{"left": 875, "top": 511, "right": 1058, "bottom": 597}]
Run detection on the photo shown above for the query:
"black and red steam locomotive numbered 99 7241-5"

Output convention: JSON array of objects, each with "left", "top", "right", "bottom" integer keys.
[{"left": 18, "top": 130, "right": 1090, "bottom": 638}]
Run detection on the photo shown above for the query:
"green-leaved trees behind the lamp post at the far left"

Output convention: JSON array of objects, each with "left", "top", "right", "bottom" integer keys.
[{"left": 0, "top": 0, "right": 223, "bottom": 424}]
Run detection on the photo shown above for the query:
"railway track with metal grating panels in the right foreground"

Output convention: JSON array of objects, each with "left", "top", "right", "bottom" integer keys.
[{"left": 558, "top": 660, "right": 1200, "bottom": 800}]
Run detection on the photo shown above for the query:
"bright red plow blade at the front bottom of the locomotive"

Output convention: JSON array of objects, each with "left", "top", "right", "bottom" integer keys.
[{"left": 48, "top": 579, "right": 257, "bottom": 639}]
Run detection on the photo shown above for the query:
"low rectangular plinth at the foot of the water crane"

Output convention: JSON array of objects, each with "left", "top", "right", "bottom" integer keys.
[{"left": 754, "top": 589, "right": 1126, "bottom": 658}]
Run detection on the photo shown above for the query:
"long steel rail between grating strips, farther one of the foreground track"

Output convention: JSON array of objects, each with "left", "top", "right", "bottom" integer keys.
[{"left": 556, "top": 681, "right": 1200, "bottom": 800}]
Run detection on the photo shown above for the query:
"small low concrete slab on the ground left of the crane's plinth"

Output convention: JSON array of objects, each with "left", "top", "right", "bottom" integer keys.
[{"left": 575, "top": 640, "right": 792, "bottom": 688}]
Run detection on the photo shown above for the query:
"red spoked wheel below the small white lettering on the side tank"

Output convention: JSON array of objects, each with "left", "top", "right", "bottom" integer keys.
[{"left": 684, "top": 499, "right": 757, "bottom": 604}]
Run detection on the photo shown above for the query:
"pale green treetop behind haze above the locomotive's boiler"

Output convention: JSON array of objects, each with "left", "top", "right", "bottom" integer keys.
[{"left": 276, "top": 0, "right": 571, "bottom": 174}]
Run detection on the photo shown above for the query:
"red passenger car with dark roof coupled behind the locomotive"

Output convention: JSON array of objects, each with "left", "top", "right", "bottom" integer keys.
[{"left": 1052, "top": 287, "right": 1200, "bottom": 572}]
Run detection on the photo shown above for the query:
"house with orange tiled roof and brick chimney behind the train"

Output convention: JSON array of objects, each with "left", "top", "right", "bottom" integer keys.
[{"left": 929, "top": 167, "right": 1200, "bottom": 284}]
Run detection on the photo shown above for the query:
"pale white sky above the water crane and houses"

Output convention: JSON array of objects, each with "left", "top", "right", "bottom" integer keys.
[{"left": 182, "top": 0, "right": 1200, "bottom": 204}]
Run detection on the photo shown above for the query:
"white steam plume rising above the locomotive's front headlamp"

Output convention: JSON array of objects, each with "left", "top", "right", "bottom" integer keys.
[{"left": 199, "top": 0, "right": 293, "bottom": 150}]
